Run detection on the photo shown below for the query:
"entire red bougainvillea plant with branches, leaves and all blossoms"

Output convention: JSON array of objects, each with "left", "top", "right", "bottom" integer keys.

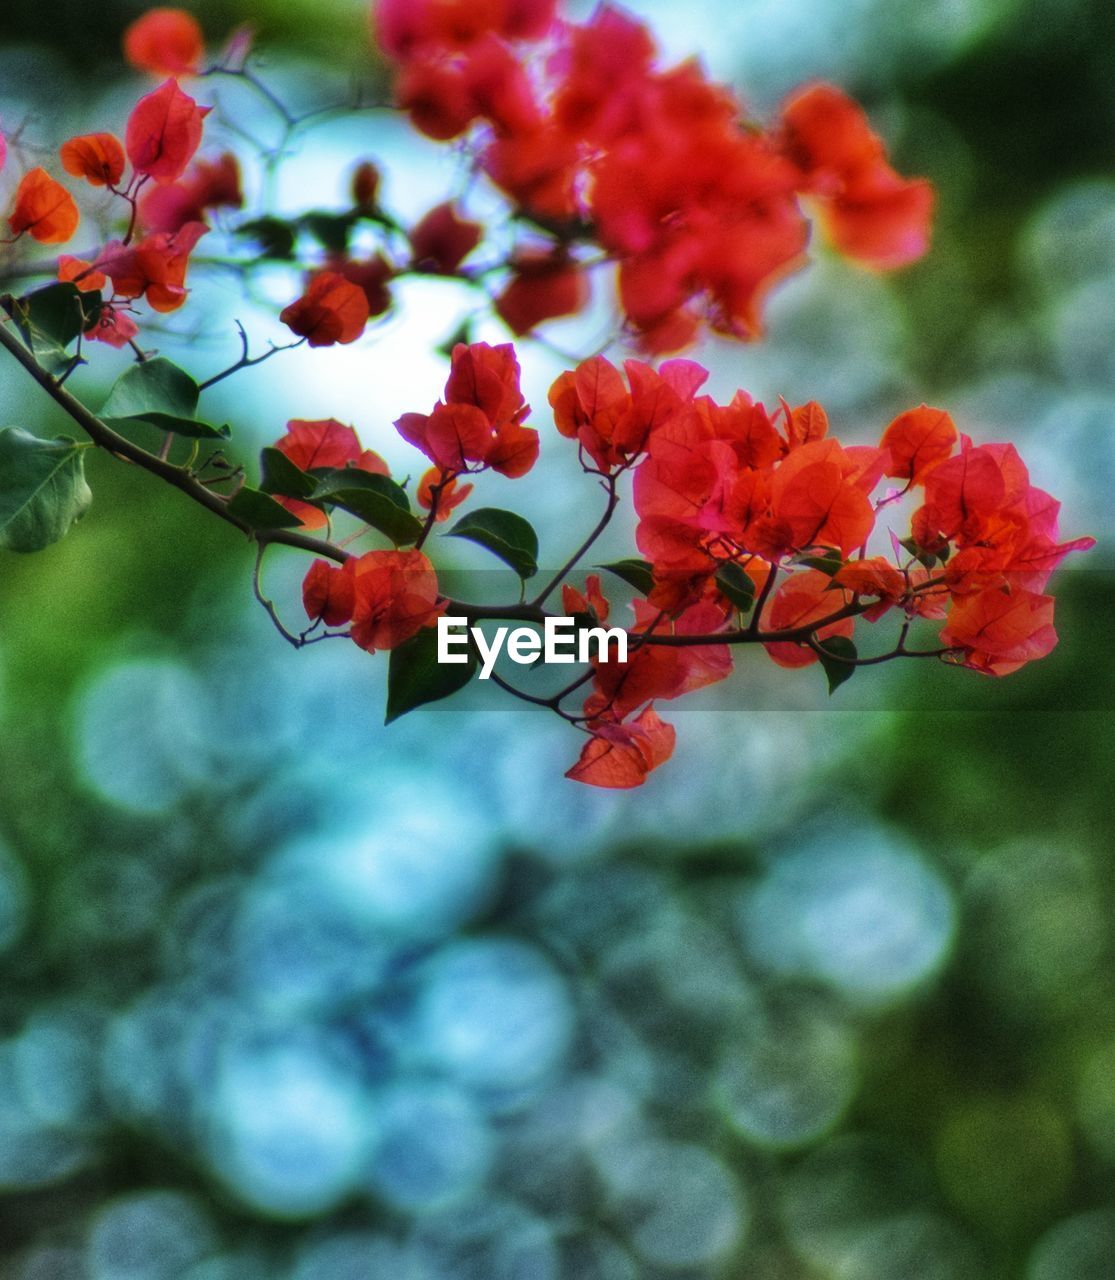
[{"left": 0, "top": 0, "right": 1092, "bottom": 787}]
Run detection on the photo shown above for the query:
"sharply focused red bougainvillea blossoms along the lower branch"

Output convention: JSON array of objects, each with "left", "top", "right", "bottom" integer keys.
[{"left": 277, "top": 343, "right": 1093, "bottom": 787}]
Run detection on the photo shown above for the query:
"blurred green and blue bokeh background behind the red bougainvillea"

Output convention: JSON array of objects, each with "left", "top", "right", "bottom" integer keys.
[{"left": 0, "top": 0, "right": 1115, "bottom": 1280}]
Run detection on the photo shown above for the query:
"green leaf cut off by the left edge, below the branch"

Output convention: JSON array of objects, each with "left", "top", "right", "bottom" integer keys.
[{"left": 0, "top": 426, "right": 93, "bottom": 552}]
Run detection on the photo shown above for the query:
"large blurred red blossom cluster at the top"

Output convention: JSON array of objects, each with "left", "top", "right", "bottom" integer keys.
[{"left": 375, "top": 0, "right": 933, "bottom": 352}]
